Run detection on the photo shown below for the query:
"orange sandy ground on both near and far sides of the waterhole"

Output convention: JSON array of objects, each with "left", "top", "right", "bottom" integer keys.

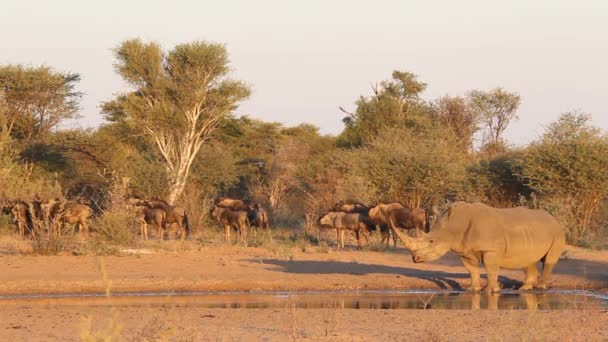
[{"left": 0, "top": 247, "right": 608, "bottom": 341}]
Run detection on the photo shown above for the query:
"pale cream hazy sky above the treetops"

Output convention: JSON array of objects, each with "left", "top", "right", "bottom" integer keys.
[{"left": 0, "top": 0, "right": 608, "bottom": 144}]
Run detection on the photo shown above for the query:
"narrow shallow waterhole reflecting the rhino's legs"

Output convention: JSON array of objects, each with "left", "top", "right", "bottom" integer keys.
[{"left": 0, "top": 290, "right": 608, "bottom": 310}]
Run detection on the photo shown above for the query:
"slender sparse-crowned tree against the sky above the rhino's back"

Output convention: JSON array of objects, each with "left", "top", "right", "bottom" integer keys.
[{"left": 468, "top": 88, "right": 521, "bottom": 154}]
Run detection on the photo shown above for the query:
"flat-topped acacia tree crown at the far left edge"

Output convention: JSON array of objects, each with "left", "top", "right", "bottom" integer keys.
[{"left": 0, "top": 65, "right": 82, "bottom": 143}]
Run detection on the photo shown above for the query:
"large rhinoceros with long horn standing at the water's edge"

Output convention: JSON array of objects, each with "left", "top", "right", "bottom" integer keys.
[{"left": 394, "top": 202, "right": 566, "bottom": 292}]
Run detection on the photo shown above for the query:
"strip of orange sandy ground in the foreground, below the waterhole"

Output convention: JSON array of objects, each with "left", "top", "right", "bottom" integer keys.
[{"left": 0, "top": 306, "right": 608, "bottom": 341}]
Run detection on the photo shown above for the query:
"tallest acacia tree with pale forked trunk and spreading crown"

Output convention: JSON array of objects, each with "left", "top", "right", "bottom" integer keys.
[{"left": 103, "top": 39, "right": 250, "bottom": 203}]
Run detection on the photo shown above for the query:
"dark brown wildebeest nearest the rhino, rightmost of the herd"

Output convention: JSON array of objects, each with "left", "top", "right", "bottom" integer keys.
[{"left": 369, "top": 203, "right": 428, "bottom": 246}]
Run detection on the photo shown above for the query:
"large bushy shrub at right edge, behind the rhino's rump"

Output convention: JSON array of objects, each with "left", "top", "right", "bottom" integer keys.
[{"left": 519, "top": 113, "right": 608, "bottom": 244}]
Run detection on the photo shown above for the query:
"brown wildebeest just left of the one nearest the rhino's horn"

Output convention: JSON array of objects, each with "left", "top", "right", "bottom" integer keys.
[{"left": 317, "top": 211, "right": 371, "bottom": 248}]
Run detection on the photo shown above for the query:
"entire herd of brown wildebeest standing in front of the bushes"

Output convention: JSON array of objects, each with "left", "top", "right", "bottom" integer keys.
[{"left": 0, "top": 196, "right": 429, "bottom": 248}]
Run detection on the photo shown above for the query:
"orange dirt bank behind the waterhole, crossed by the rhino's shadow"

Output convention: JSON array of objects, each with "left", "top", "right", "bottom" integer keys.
[{"left": 0, "top": 247, "right": 608, "bottom": 294}]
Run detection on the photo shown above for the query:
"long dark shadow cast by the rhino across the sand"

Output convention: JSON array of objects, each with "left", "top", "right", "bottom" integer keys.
[{"left": 250, "top": 259, "right": 522, "bottom": 291}]
